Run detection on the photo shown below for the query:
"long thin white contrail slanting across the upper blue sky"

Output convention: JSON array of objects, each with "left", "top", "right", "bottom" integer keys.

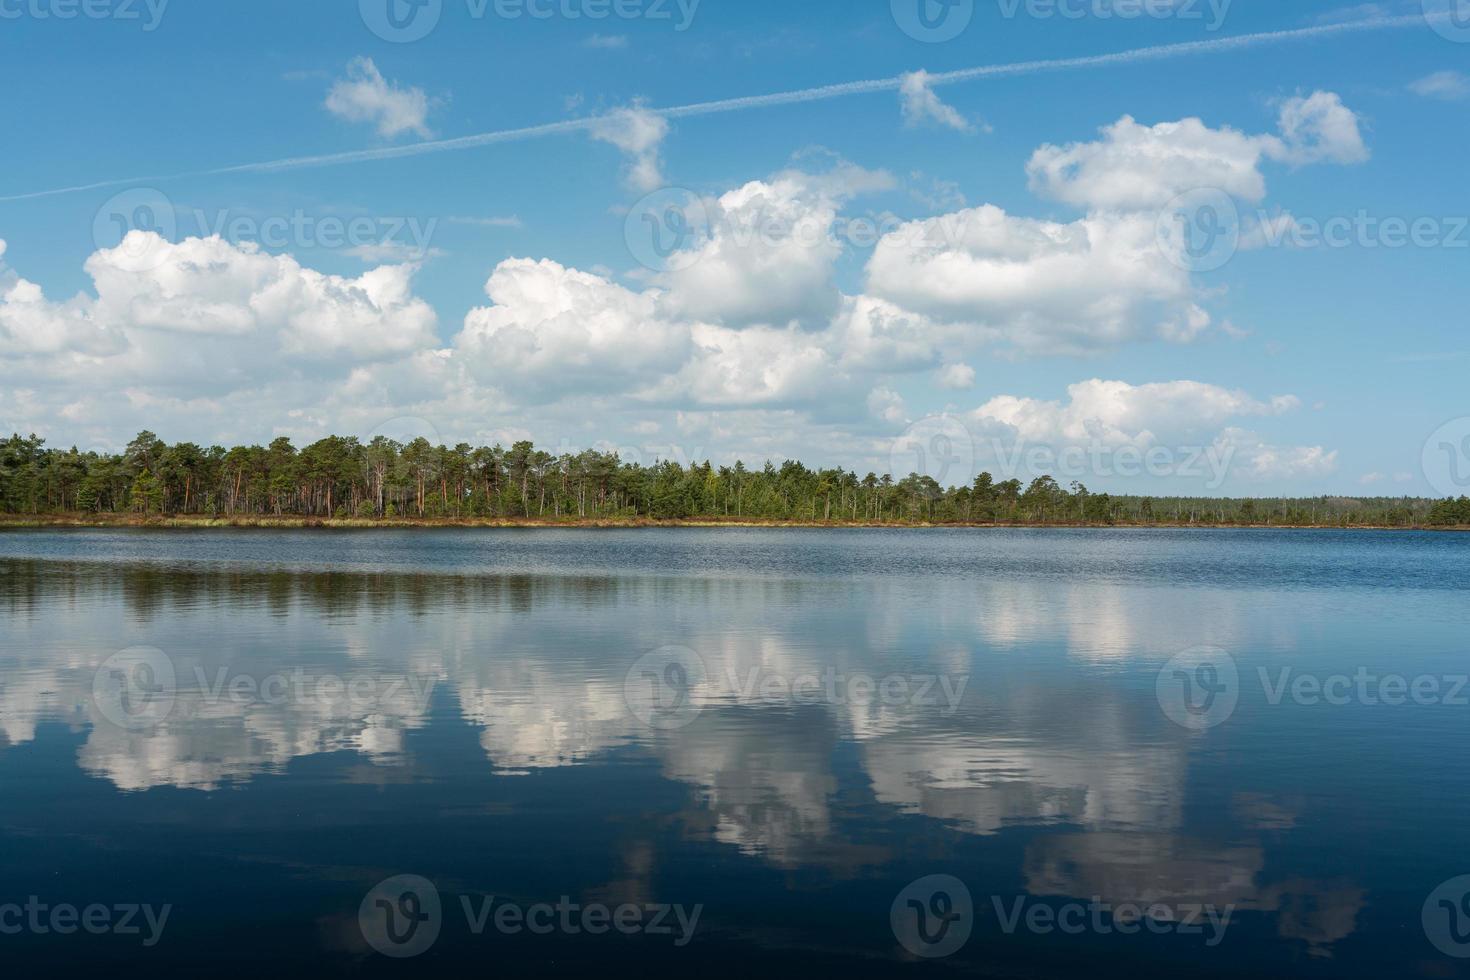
[{"left": 0, "top": 15, "right": 1448, "bottom": 203}]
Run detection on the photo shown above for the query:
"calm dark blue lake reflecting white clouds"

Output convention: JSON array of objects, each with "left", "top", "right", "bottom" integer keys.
[{"left": 0, "top": 529, "right": 1470, "bottom": 977}]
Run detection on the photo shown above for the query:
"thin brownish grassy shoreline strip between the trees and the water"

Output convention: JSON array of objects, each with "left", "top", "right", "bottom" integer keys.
[{"left": 0, "top": 514, "right": 1470, "bottom": 532}]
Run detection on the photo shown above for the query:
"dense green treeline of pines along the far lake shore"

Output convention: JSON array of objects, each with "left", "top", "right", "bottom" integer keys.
[{"left": 0, "top": 432, "right": 1470, "bottom": 527}]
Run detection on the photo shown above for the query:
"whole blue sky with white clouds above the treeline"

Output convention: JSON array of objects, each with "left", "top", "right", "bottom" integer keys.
[{"left": 0, "top": 0, "right": 1470, "bottom": 494}]
